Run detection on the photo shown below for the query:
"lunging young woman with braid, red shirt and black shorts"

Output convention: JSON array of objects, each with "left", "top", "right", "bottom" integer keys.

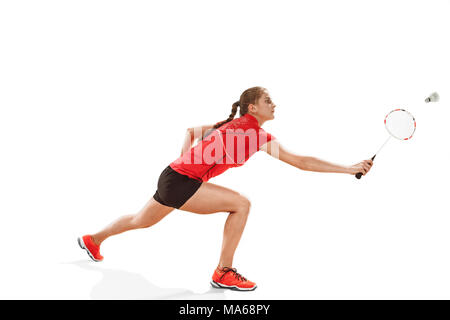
[{"left": 78, "top": 87, "right": 373, "bottom": 291}]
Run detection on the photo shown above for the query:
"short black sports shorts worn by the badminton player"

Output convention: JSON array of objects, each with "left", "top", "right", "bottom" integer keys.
[{"left": 153, "top": 166, "right": 202, "bottom": 209}]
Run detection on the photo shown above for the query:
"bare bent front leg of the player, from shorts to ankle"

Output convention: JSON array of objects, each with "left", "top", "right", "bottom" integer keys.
[{"left": 180, "top": 182, "right": 250, "bottom": 268}]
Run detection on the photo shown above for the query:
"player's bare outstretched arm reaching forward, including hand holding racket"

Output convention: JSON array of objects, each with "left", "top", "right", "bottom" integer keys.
[{"left": 260, "top": 140, "right": 373, "bottom": 175}]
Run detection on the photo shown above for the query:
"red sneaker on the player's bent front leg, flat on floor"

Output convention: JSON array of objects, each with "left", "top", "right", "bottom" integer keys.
[{"left": 211, "top": 267, "right": 256, "bottom": 291}]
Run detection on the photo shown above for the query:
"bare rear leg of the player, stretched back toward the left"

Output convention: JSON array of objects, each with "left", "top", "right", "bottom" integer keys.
[{"left": 91, "top": 197, "right": 174, "bottom": 245}]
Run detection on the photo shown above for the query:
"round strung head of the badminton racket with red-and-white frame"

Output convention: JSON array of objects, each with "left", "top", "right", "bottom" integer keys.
[{"left": 384, "top": 109, "right": 416, "bottom": 140}]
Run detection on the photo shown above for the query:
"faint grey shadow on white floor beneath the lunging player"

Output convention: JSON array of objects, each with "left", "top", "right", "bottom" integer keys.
[{"left": 68, "top": 260, "right": 226, "bottom": 300}]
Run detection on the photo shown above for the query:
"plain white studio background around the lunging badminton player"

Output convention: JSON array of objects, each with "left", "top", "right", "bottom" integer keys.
[{"left": 0, "top": 0, "right": 450, "bottom": 299}]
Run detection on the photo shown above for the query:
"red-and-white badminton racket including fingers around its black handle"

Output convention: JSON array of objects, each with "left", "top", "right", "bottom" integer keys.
[{"left": 354, "top": 109, "right": 416, "bottom": 179}]
